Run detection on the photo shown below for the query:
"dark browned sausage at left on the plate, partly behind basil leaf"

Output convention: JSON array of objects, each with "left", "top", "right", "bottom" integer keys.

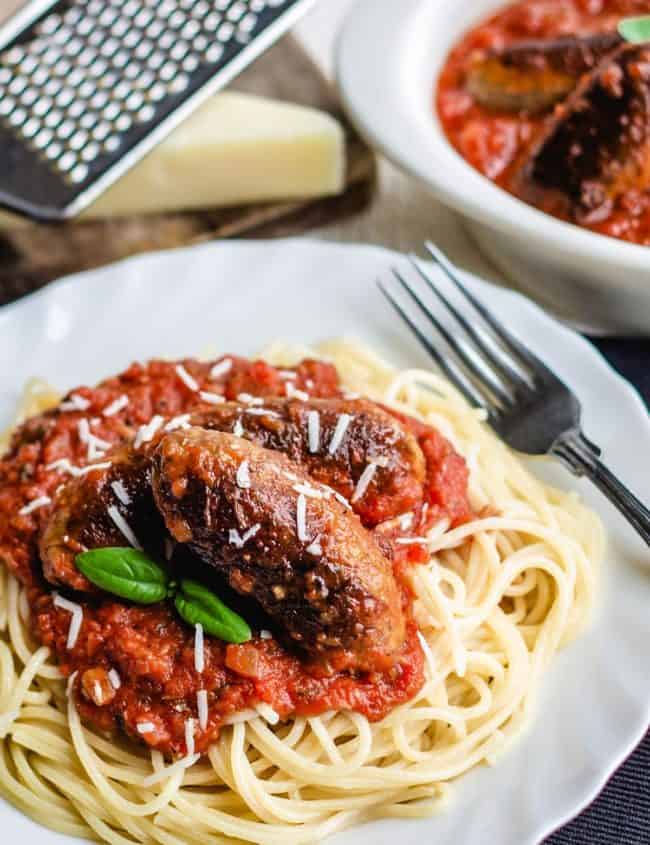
[{"left": 39, "top": 445, "right": 168, "bottom": 592}]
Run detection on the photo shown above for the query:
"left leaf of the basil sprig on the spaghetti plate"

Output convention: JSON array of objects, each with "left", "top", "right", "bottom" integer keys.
[{"left": 76, "top": 546, "right": 169, "bottom": 604}]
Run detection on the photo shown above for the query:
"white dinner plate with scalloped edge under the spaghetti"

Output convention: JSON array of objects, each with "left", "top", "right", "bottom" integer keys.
[{"left": 0, "top": 240, "right": 650, "bottom": 845}]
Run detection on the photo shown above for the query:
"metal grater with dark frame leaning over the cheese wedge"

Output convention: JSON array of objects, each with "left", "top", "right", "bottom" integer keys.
[{"left": 0, "top": 0, "right": 313, "bottom": 220}]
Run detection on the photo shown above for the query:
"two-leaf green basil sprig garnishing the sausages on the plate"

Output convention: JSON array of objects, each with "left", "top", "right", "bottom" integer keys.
[{"left": 76, "top": 546, "right": 252, "bottom": 643}]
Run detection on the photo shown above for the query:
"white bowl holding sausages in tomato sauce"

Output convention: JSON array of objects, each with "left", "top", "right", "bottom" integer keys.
[{"left": 337, "top": 0, "right": 650, "bottom": 334}]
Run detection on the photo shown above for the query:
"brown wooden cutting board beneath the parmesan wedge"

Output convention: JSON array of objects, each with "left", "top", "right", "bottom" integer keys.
[{"left": 0, "top": 36, "right": 376, "bottom": 305}]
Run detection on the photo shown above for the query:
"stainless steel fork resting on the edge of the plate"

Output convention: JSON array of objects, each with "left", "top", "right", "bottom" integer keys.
[{"left": 378, "top": 243, "right": 650, "bottom": 545}]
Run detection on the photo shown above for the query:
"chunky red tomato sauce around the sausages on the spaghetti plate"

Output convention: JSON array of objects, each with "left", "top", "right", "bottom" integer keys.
[{"left": 0, "top": 358, "right": 471, "bottom": 753}]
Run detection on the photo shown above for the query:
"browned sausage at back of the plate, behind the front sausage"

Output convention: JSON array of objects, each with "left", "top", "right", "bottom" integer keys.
[{"left": 191, "top": 399, "right": 426, "bottom": 528}]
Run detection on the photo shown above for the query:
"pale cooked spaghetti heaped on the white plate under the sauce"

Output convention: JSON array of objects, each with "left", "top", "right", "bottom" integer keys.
[{"left": 0, "top": 342, "right": 603, "bottom": 845}]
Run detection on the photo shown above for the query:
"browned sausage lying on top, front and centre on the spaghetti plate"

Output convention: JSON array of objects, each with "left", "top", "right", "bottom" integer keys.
[{"left": 152, "top": 428, "right": 405, "bottom": 670}]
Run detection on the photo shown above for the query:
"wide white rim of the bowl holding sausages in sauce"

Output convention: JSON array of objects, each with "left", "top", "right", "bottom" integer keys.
[{"left": 335, "top": 0, "right": 650, "bottom": 276}]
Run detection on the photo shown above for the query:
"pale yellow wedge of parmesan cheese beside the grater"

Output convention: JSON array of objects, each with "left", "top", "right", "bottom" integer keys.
[{"left": 0, "top": 91, "right": 346, "bottom": 226}]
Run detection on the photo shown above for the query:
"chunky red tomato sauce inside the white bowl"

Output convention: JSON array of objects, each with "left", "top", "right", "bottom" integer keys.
[{"left": 436, "top": 0, "right": 650, "bottom": 246}]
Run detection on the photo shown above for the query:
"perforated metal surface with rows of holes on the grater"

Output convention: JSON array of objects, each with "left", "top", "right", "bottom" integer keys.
[{"left": 0, "top": 0, "right": 294, "bottom": 182}]
